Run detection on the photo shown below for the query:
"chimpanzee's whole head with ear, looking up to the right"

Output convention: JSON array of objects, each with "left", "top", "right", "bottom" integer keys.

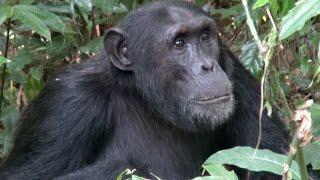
[{"left": 104, "top": 1, "right": 234, "bottom": 130}]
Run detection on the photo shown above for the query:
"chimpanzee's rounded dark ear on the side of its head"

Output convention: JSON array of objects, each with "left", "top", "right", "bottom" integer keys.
[{"left": 103, "top": 28, "right": 132, "bottom": 71}]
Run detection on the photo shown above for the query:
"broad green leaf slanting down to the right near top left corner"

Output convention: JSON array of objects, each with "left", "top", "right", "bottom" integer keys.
[{"left": 13, "top": 5, "right": 51, "bottom": 40}]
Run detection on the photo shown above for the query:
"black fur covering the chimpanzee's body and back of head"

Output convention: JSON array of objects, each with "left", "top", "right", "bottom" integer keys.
[{"left": 0, "top": 2, "right": 289, "bottom": 179}]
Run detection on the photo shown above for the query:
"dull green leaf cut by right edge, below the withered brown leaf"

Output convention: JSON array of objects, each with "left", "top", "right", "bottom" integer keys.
[{"left": 303, "top": 142, "right": 320, "bottom": 170}]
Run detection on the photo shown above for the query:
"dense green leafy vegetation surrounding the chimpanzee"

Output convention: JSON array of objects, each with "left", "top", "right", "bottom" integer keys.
[{"left": 0, "top": 0, "right": 320, "bottom": 179}]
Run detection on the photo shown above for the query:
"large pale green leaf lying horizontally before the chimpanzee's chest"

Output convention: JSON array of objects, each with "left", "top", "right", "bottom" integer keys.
[{"left": 204, "top": 147, "right": 301, "bottom": 179}]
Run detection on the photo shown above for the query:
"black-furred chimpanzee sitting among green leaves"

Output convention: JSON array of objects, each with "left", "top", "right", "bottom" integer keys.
[{"left": 0, "top": 1, "right": 289, "bottom": 179}]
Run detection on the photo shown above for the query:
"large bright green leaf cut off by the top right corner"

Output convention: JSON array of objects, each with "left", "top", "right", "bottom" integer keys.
[{"left": 279, "top": 0, "right": 320, "bottom": 40}]
